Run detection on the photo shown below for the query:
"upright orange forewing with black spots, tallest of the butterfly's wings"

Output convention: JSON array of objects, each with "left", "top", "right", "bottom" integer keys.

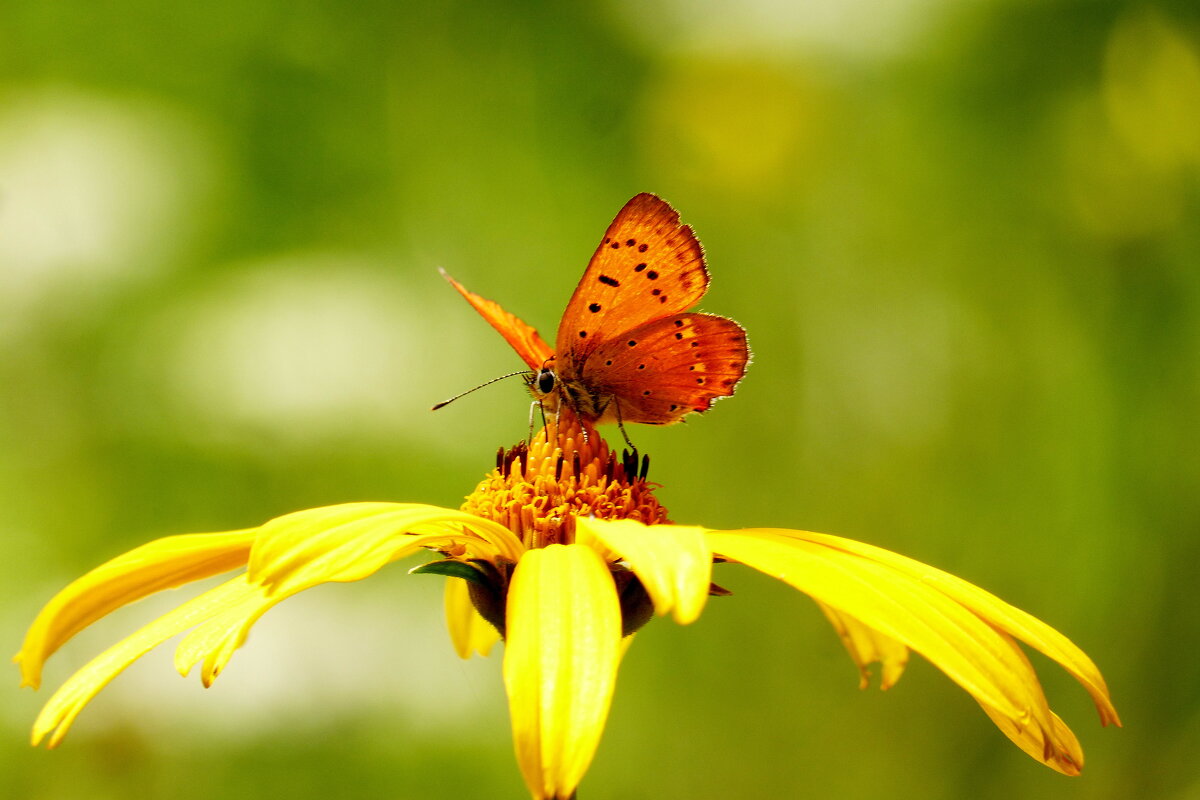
[{"left": 554, "top": 193, "right": 708, "bottom": 371}]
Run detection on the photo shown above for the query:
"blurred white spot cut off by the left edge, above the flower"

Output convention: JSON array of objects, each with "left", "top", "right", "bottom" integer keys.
[{"left": 0, "top": 89, "right": 211, "bottom": 335}]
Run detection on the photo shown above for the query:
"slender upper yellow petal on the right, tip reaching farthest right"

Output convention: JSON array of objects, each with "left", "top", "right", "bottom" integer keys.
[{"left": 779, "top": 531, "right": 1121, "bottom": 726}]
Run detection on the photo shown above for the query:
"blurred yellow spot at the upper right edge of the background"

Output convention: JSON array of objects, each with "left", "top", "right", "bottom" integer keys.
[{"left": 1103, "top": 11, "right": 1200, "bottom": 169}]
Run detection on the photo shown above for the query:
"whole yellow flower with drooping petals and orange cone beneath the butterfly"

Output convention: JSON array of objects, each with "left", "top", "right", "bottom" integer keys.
[{"left": 16, "top": 411, "right": 1120, "bottom": 800}]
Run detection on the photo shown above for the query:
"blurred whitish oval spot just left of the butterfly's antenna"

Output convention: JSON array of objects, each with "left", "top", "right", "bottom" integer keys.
[{"left": 151, "top": 253, "right": 449, "bottom": 441}]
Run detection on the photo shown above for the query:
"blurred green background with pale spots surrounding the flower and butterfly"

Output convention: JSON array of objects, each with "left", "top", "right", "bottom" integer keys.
[{"left": 0, "top": 0, "right": 1200, "bottom": 800}]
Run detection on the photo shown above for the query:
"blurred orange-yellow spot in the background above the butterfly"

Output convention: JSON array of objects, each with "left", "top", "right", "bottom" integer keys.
[{"left": 642, "top": 62, "right": 828, "bottom": 194}]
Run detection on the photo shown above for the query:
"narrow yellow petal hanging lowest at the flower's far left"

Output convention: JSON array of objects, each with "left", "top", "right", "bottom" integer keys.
[{"left": 32, "top": 576, "right": 256, "bottom": 747}]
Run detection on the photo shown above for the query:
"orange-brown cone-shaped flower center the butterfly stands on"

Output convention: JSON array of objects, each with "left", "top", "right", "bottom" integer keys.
[{"left": 462, "top": 408, "right": 668, "bottom": 547}]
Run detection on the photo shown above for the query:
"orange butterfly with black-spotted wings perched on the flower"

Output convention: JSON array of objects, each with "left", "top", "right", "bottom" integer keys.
[{"left": 434, "top": 193, "right": 750, "bottom": 429}]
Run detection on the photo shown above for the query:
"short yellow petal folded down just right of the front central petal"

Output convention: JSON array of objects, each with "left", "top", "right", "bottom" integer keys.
[{"left": 575, "top": 517, "right": 713, "bottom": 625}]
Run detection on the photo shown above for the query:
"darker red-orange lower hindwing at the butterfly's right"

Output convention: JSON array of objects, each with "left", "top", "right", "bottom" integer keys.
[{"left": 580, "top": 314, "right": 750, "bottom": 425}]
